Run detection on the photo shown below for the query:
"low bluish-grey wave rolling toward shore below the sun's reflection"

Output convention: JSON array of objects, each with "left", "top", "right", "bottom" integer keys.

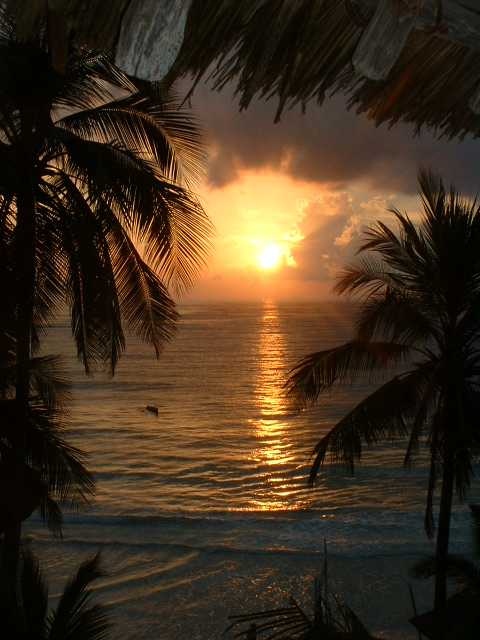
[{"left": 26, "top": 500, "right": 450, "bottom": 558}]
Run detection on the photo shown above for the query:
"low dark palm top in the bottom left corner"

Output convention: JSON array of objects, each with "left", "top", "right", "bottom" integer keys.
[{"left": 0, "top": 550, "right": 110, "bottom": 640}]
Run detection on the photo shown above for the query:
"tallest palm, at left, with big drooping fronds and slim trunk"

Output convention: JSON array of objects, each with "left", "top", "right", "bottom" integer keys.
[{"left": 0, "top": 16, "right": 212, "bottom": 580}]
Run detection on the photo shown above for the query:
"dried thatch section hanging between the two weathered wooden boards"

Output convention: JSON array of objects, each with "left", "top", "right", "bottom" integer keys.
[{"left": 167, "top": 0, "right": 361, "bottom": 120}]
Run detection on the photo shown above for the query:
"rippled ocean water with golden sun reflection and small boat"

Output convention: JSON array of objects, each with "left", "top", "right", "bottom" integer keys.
[{"left": 24, "top": 300, "right": 478, "bottom": 640}]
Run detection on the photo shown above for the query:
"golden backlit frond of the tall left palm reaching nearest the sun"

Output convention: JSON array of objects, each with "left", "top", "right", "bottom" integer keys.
[{"left": 51, "top": 134, "right": 214, "bottom": 291}]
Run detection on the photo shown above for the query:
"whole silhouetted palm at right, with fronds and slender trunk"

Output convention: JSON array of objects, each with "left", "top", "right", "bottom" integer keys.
[{"left": 287, "top": 170, "right": 480, "bottom": 638}]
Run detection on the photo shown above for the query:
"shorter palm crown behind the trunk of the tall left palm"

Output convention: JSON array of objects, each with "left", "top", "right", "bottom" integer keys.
[{"left": 0, "top": 356, "right": 95, "bottom": 535}]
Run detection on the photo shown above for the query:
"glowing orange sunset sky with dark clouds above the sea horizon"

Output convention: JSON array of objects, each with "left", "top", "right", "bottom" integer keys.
[{"left": 179, "top": 79, "right": 480, "bottom": 300}]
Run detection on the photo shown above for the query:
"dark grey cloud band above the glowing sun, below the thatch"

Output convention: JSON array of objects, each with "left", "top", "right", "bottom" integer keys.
[{"left": 192, "top": 86, "right": 480, "bottom": 195}]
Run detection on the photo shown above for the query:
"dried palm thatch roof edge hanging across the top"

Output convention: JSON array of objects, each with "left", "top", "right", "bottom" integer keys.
[{"left": 4, "top": 0, "right": 480, "bottom": 139}]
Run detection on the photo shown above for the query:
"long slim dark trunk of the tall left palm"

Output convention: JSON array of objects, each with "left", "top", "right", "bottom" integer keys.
[{"left": 3, "top": 182, "right": 36, "bottom": 587}]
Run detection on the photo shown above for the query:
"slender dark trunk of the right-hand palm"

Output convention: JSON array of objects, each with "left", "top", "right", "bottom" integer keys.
[{"left": 434, "top": 446, "right": 455, "bottom": 640}]
